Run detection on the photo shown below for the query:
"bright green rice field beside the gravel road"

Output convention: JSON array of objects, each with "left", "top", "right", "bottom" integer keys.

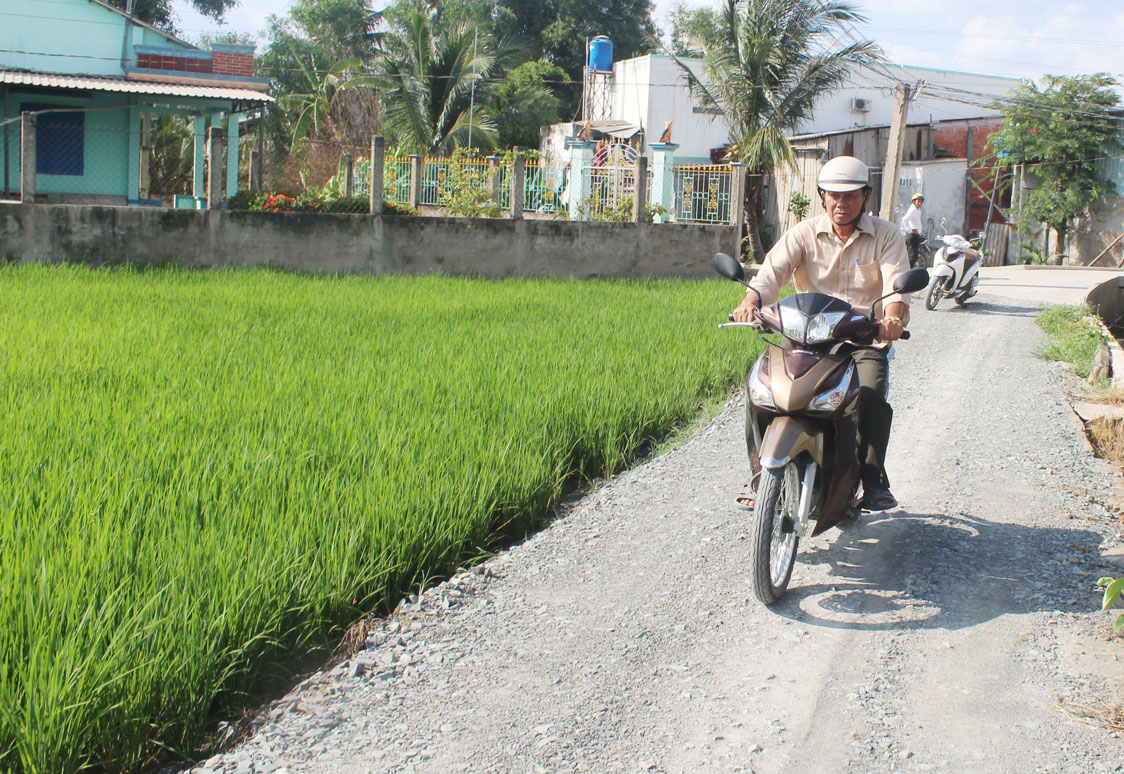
[{"left": 0, "top": 265, "right": 759, "bottom": 773}]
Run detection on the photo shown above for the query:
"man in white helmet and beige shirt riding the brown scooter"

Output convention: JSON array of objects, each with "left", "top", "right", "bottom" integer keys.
[{"left": 732, "top": 156, "right": 909, "bottom": 511}]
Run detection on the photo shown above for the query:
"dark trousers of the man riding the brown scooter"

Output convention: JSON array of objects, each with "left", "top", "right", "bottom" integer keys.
[{"left": 745, "top": 347, "right": 894, "bottom": 492}]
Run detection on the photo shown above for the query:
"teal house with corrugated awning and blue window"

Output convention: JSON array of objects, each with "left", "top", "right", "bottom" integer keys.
[{"left": 0, "top": 0, "right": 272, "bottom": 206}]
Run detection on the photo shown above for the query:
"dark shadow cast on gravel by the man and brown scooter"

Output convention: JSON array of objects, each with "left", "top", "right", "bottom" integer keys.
[{"left": 772, "top": 511, "right": 1100, "bottom": 631}]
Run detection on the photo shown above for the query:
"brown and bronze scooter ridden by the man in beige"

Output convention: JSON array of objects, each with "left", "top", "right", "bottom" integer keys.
[{"left": 714, "top": 253, "right": 928, "bottom": 604}]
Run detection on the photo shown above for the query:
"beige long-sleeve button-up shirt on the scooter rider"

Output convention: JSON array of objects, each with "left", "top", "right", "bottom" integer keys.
[{"left": 750, "top": 213, "right": 909, "bottom": 324}]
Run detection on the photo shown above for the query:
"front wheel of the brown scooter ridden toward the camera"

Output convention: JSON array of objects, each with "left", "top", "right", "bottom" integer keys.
[{"left": 750, "top": 462, "right": 800, "bottom": 604}]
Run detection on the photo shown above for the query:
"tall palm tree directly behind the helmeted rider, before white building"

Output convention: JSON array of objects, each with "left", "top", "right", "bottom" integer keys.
[{"left": 679, "top": 0, "right": 882, "bottom": 259}]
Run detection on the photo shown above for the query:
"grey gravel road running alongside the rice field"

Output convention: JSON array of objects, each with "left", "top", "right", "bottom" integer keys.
[{"left": 193, "top": 293, "right": 1124, "bottom": 774}]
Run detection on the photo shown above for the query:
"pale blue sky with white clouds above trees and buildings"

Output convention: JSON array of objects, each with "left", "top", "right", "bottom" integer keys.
[{"left": 168, "top": 0, "right": 1124, "bottom": 82}]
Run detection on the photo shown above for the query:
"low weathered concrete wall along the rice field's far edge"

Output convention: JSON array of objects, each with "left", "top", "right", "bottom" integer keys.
[{"left": 0, "top": 203, "right": 738, "bottom": 277}]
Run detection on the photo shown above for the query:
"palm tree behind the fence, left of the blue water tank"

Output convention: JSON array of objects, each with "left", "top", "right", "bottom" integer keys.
[{"left": 375, "top": 10, "right": 496, "bottom": 153}]
